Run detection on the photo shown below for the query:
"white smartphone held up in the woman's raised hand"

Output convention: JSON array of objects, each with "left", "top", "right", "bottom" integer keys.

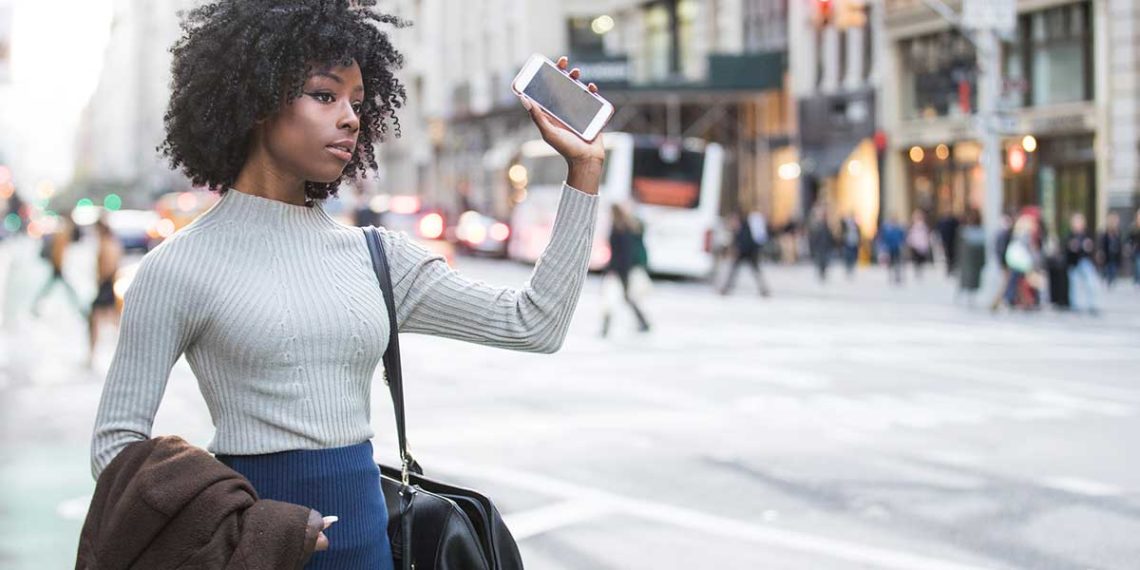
[{"left": 511, "top": 54, "right": 613, "bottom": 141}]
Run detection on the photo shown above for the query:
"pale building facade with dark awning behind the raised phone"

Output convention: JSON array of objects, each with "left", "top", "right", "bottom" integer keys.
[{"left": 378, "top": 0, "right": 792, "bottom": 217}]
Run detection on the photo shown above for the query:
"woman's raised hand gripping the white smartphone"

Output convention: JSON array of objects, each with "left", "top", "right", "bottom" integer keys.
[{"left": 521, "top": 56, "right": 605, "bottom": 194}]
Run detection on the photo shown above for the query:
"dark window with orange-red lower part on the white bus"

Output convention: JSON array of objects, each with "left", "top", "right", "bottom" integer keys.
[{"left": 633, "top": 147, "right": 705, "bottom": 209}]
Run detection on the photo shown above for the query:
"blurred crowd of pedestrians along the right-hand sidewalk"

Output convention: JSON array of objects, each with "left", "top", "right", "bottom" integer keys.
[{"left": 714, "top": 204, "right": 1140, "bottom": 315}]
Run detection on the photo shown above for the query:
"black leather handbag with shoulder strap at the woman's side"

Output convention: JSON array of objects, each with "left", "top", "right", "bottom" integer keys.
[{"left": 364, "top": 228, "right": 522, "bottom": 570}]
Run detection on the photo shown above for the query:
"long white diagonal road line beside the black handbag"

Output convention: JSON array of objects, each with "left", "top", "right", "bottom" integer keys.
[{"left": 432, "top": 458, "right": 984, "bottom": 570}]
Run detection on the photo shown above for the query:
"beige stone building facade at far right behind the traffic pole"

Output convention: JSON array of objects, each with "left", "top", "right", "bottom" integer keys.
[{"left": 885, "top": 0, "right": 1140, "bottom": 233}]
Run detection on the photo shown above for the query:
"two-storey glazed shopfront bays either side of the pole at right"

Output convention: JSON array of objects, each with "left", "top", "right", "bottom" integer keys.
[{"left": 888, "top": 2, "right": 1104, "bottom": 233}]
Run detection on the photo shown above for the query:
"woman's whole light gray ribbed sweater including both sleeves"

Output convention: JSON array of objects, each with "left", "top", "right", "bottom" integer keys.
[{"left": 91, "top": 186, "right": 597, "bottom": 478}]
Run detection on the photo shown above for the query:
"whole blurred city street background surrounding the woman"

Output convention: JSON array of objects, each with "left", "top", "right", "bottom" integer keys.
[{"left": 0, "top": 0, "right": 1140, "bottom": 570}]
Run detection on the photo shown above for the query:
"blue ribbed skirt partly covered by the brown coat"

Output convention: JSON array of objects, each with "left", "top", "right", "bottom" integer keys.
[{"left": 217, "top": 441, "right": 392, "bottom": 570}]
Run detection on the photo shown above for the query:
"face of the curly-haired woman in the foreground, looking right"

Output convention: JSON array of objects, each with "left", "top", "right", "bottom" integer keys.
[{"left": 261, "top": 62, "right": 365, "bottom": 184}]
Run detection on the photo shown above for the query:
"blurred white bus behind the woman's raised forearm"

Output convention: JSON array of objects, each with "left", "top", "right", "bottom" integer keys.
[{"left": 507, "top": 132, "right": 724, "bottom": 278}]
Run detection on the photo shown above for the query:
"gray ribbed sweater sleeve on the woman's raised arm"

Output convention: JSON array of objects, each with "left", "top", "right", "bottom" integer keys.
[{"left": 381, "top": 186, "right": 597, "bottom": 353}]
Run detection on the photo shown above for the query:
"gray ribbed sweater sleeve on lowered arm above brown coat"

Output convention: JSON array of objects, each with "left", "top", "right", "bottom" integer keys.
[{"left": 91, "top": 242, "right": 194, "bottom": 479}]
